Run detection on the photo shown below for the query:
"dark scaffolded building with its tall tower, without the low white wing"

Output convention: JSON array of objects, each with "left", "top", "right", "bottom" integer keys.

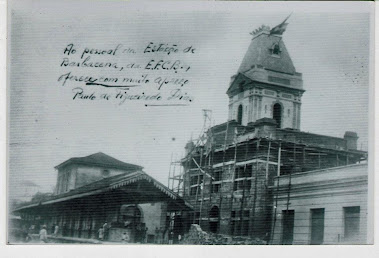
[{"left": 169, "top": 22, "right": 367, "bottom": 244}]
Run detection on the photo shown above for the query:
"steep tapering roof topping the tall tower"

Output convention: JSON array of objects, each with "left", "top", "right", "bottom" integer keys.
[{"left": 238, "top": 29, "right": 296, "bottom": 74}]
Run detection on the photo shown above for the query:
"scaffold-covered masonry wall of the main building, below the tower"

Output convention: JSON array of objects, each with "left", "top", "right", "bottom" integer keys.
[{"left": 185, "top": 155, "right": 277, "bottom": 239}]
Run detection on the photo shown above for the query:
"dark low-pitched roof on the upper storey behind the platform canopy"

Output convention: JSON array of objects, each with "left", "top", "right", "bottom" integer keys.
[{"left": 55, "top": 152, "right": 142, "bottom": 170}]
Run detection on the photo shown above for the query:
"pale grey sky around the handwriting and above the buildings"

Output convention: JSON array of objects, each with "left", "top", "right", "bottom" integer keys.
[{"left": 8, "top": 2, "right": 370, "bottom": 202}]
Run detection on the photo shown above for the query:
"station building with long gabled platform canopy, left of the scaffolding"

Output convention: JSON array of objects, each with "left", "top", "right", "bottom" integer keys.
[{"left": 13, "top": 152, "right": 191, "bottom": 243}]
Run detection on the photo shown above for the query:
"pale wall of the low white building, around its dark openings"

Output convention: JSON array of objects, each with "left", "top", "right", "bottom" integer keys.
[{"left": 272, "top": 164, "right": 368, "bottom": 245}]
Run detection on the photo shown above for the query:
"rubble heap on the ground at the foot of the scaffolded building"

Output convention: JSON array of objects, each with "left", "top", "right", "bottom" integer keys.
[{"left": 181, "top": 224, "right": 267, "bottom": 245}]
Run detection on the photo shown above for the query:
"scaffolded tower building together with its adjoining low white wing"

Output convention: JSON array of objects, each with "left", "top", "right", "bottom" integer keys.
[{"left": 177, "top": 23, "right": 368, "bottom": 244}]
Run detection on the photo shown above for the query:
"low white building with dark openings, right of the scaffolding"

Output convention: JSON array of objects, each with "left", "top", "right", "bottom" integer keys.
[{"left": 271, "top": 164, "right": 368, "bottom": 245}]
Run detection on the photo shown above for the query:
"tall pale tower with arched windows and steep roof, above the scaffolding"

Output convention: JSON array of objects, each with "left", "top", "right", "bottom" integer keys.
[{"left": 227, "top": 21, "right": 304, "bottom": 130}]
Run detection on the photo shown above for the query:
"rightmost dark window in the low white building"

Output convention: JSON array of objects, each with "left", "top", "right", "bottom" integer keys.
[{"left": 343, "top": 206, "right": 360, "bottom": 242}]
